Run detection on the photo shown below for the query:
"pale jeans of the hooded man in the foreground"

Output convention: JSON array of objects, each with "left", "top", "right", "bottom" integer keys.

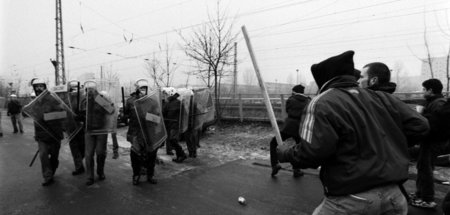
[{"left": 313, "top": 185, "right": 408, "bottom": 215}]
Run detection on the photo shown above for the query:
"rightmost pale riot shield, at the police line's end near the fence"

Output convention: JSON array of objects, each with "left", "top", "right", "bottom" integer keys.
[{"left": 192, "top": 88, "right": 214, "bottom": 129}]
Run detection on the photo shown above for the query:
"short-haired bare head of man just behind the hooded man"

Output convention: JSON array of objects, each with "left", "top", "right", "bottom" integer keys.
[{"left": 359, "top": 62, "right": 397, "bottom": 94}]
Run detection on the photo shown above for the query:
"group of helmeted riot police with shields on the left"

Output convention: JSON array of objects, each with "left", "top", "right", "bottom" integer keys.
[{"left": 13, "top": 78, "right": 206, "bottom": 186}]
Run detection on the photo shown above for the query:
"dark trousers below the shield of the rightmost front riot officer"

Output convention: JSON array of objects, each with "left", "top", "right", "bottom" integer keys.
[{"left": 130, "top": 149, "right": 158, "bottom": 178}]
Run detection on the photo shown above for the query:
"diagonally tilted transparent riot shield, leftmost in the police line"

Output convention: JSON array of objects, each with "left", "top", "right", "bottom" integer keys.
[{"left": 23, "top": 90, "right": 82, "bottom": 141}]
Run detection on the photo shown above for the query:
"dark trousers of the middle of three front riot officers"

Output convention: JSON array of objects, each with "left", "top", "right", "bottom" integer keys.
[{"left": 85, "top": 134, "right": 108, "bottom": 179}]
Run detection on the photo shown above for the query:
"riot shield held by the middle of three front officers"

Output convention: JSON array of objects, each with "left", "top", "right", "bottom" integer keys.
[{"left": 85, "top": 88, "right": 117, "bottom": 135}]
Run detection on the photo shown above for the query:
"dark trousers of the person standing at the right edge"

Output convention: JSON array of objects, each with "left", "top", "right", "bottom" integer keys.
[{"left": 416, "top": 142, "right": 440, "bottom": 202}]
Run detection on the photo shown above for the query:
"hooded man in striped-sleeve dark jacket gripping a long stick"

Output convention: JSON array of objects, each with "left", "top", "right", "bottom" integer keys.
[{"left": 277, "top": 51, "right": 429, "bottom": 214}]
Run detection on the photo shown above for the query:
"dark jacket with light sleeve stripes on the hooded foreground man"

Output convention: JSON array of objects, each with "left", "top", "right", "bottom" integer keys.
[{"left": 284, "top": 75, "right": 429, "bottom": 196}]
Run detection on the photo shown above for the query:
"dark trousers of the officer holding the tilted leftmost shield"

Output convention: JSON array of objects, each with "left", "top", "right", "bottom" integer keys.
[{"left": 38, "top": 140, "right": 61, "bottom": 180}]
